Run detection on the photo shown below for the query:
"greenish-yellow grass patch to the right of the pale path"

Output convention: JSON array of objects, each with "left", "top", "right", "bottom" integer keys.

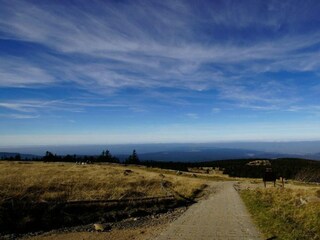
[{"left": 241, "top": 188, "right": 320, "bottom": 240}]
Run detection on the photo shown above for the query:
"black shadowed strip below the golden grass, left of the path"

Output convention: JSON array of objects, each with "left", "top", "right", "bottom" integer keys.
[{"left": 0, "top": 196, "right": 191, "bottom": 234}]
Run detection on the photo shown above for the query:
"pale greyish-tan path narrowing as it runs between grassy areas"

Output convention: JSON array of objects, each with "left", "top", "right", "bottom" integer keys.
[{"left": 156, "top": 182, "right": 262, "bottom": 240}]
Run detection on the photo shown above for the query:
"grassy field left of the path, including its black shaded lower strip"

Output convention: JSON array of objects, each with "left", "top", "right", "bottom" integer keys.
[{"left": 0, "top": 161, "right": 208, "bottom": 233}]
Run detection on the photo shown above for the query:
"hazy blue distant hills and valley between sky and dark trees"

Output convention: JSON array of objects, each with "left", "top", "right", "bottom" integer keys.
[{"left": 0, "top": 141, "right": 320, "bottom": 162}]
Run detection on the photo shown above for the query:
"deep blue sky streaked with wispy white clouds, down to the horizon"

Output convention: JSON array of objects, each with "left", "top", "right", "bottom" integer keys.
[{"left": 0, "top": 0, "right": 320, "bottom": 146}]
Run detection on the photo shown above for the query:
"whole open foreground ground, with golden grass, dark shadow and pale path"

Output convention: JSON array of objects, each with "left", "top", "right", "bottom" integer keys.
[{"left": 0, "top": 161, "right": 320, "bottom": 240}]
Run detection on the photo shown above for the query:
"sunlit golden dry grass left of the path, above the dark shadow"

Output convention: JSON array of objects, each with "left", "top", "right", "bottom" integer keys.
[{"left": 0, "top": 162, "right": 205, "bottom": 201}]
